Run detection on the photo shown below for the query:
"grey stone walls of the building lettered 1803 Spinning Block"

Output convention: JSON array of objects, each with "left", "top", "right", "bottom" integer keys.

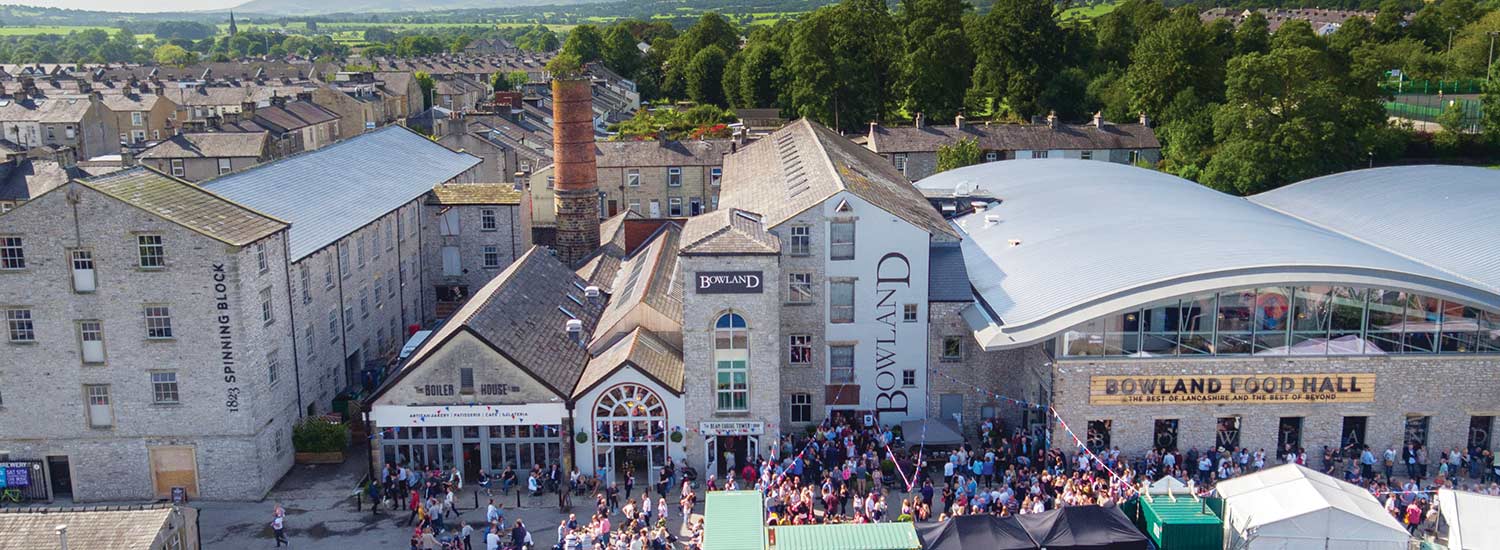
[{"left": 0, "top": 186, "right": 297, "bottom": 502}]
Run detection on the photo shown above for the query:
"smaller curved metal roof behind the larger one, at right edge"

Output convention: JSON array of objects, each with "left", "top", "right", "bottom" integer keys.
[{"left": 1250, "top": 166, "right": 1500, "bottom": 299}]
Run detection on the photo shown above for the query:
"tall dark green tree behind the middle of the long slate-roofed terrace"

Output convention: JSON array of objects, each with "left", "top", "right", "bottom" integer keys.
[{"left": 971, "top": 0, "right": 1062, "bottom": 120}]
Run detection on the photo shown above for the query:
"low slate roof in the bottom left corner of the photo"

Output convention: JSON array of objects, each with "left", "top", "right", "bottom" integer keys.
[{"left": 0, "top": 505, "right": 184, "bottom": 550}]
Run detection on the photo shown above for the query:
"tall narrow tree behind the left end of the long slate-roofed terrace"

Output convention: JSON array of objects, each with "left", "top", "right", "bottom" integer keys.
[{"left": 897, "top": 0, "right": 974, "bottom": 118}]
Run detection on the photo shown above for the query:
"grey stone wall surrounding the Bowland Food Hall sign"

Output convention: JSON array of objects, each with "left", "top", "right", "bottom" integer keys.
[{"left": 1053, "top": 355, "right": 1500, "bottom": 457}]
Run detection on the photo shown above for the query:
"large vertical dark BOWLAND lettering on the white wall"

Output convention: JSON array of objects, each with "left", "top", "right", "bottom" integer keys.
[{"left": 875, "top": 252, "right": 912, "bottom": 415}]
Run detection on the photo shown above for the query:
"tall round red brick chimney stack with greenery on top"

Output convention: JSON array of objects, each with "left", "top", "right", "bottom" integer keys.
[{"left": 552, "top": 78, "right": 599, "bottom": 265}]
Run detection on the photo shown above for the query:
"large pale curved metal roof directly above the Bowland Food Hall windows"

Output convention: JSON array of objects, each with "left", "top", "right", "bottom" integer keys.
[{"left": 917, "top": 159, "right": 1500, "bottom": 349}]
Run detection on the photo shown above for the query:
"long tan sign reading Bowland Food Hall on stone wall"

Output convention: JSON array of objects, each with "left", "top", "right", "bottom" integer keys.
[{"left": 1089, "top": 373, "right": 1376, "bottom": 405}]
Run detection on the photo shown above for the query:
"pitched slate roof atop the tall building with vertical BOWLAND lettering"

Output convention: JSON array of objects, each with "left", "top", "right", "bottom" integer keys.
[{"left": 719, "top": 118, "right": 957, "bottom": 237}]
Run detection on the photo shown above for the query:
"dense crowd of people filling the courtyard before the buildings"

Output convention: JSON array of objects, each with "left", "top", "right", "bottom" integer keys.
[{"left": 372, "top": 415, "right": 1500, "bottom": 550}]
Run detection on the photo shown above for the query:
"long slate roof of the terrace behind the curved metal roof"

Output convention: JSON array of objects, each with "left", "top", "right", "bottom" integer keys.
[{"left": 870, "top": 123, "right": 1161, "bottom": 154}]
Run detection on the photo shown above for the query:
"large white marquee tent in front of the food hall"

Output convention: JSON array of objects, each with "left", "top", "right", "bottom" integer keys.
[{"left": 1218, "top": 465, "right": 1409, "bottom": 550}]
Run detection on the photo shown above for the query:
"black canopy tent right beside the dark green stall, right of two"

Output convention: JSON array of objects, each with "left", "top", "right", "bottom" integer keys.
[{"left": 1019, "top": 507, "right": 1146, "bottom": 550}]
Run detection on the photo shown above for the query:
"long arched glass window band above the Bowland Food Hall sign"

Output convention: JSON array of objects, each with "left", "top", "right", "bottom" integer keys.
[{"left": 1056, "top": 285, "right": 1500, "bottom": 357}]
